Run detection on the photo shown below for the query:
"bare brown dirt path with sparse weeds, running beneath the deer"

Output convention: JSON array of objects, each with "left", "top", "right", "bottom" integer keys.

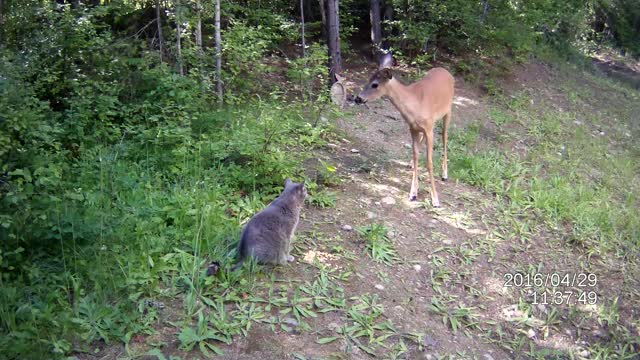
[{"left": 91, "top": 57, "right": 640, "bottom": 360}]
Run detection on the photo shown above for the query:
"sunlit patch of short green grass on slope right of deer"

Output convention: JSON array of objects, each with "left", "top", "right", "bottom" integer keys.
[{"left": 452, "top": 91, "right": 640, "bottom": 254}]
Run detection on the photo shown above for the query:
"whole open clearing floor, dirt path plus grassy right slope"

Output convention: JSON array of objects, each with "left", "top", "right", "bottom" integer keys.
[{"left": 82, "top": 54, "right": 640, "bottom": 359}]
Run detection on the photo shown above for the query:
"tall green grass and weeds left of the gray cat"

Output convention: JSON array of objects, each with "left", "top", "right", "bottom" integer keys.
[{"left": 0, "top": 97, "right": 334, "bottom": 358}]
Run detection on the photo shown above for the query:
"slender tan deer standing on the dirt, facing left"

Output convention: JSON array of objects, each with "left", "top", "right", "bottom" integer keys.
[{"left": 355, "top": 53, "right": 455, "bottom": 207}]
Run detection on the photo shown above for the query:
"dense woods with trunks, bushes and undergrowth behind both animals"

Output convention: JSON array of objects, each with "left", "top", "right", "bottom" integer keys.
[{"left": 0, "top": 0, "right": 640, "bottom": 359}]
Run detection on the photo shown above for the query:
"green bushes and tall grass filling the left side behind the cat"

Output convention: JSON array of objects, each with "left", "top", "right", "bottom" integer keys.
[{"left": 0, "top": 1, "right": 329, "bottom": 358}]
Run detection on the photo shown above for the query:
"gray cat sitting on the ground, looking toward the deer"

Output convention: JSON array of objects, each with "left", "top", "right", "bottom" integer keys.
[{"left": 232, "top": 179, "right": 307, "bottom": 270}]
